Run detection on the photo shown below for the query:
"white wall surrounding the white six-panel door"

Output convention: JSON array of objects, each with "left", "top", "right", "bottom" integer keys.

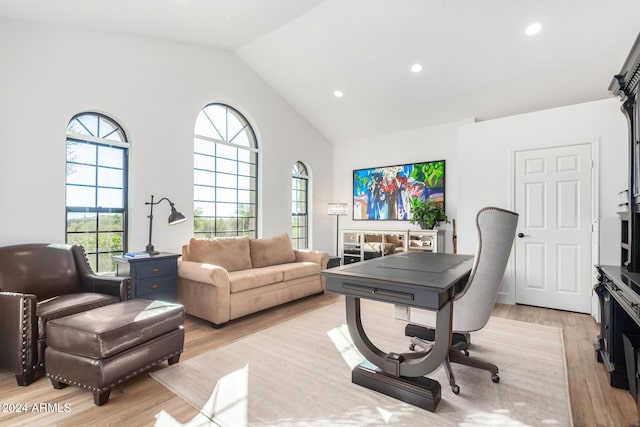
[{"left": 457, "top": 97, "right": 628, "bottom": 302}]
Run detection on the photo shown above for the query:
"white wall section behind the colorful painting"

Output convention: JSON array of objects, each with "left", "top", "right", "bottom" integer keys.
[{"left": 330, "top": 119, "right": 473, "bottom": 252}]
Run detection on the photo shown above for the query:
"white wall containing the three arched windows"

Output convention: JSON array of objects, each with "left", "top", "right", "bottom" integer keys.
[{"left": 0, "top": 18, "right": 333, "bottom": 252}]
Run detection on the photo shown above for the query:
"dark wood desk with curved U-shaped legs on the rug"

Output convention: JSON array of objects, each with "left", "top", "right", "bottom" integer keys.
[{"left": 321, "top": 252, "right": 473, "bottom": 411}]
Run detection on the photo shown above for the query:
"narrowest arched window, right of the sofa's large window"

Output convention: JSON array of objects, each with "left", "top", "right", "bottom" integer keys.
[{"left": 291, "top": 162, "right": 309, "bottom": 249}]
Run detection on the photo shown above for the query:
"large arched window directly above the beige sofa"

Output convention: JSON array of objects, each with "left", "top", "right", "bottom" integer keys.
[{"left": 193, "top": 104, "right": 258, "bottom": 237}]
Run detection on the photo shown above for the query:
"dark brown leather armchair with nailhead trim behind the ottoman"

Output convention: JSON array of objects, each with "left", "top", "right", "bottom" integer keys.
[{"left": 0, "top": 243, "right": 131, "bottom": 386}]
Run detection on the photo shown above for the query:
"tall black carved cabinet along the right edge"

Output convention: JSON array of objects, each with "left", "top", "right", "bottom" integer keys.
[{"left": 595, "top": 35, "right": 640, "bottom": 425}]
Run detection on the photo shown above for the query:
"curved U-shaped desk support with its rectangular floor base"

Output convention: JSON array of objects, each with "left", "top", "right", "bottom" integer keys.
[{"left": 345, "top": 296, "right": 452, "bottom": 412}]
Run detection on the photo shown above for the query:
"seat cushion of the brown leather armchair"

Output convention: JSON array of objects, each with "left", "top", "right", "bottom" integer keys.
[{"left": 36, "top": 292, "right": 120, "bottom": 338}]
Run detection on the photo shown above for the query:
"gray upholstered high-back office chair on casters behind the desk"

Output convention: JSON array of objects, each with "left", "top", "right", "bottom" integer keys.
[{"left": 405, "top": 207, "right": 518, "bottom": 394}]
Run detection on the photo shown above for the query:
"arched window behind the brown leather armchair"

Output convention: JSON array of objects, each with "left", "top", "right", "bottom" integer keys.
[{"left": 66, "top": 113, "right": 129, "bottom": 272}]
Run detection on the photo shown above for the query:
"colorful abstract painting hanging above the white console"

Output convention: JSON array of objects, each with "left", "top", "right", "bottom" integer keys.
[{"left": 353, "top": 160, "right": 444, "bottom": 220}]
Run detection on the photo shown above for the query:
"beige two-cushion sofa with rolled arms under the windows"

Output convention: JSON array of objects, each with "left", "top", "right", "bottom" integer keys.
[{"left": 178, "top": 234, "right": 329, "bottom": 327}]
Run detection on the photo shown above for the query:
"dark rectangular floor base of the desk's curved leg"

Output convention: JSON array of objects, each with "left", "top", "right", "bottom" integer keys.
[{"left": 351, "top": 360, "right": 441, "bottom": 412}]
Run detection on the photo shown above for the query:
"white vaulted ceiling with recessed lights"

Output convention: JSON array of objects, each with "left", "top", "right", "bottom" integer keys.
[{"left": 0, "top": 0, "right": 640, "bottom": 143}]
